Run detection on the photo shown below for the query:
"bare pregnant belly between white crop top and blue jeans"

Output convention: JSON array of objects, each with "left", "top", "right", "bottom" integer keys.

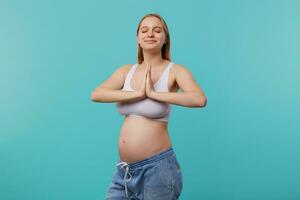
[{"left": 118, "top": 116, "right": 171, "bottom": 163}]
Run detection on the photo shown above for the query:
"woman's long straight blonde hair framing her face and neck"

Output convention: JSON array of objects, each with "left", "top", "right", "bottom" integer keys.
[{"left": 136, "top": 13, "right": 171, "bottom": 64}]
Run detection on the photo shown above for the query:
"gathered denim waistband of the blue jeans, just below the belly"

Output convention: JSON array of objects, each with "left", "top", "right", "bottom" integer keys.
[{"left": 119, "top": 146, "right": 175, "bottom": 169}]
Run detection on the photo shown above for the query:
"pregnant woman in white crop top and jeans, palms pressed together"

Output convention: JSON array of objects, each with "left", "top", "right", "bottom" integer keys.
[{"left": 91, "top": 13, "right": 207, "bottom": 200}]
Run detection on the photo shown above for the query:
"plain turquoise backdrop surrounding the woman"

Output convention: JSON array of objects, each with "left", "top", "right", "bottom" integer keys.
[{"left": 0, "top": 0, "right": 300, "bottom": 200}]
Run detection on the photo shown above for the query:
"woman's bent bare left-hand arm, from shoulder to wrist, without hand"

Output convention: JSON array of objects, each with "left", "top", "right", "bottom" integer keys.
[{"left": 90, "top": 64, "right": 144, "bottom": 103}]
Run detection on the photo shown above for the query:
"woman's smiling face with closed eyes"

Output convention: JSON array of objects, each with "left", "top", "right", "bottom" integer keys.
[{"left": 137, "top": 17, "right": 166, "bottom": 51}]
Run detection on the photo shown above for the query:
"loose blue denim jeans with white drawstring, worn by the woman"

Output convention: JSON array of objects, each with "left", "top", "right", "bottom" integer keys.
[{"left": 105, "top": 147, "right": 182, "bottom": 200}]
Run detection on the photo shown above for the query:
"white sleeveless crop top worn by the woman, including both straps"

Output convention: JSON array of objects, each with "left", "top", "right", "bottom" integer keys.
[{"left": 116, "top": 62, "right": 174, "bottom": 122}]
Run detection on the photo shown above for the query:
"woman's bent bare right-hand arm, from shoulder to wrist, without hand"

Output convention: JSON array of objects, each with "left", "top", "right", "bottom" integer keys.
[{"left": 150, "top": 64, "right": 207, "bottom": 107}]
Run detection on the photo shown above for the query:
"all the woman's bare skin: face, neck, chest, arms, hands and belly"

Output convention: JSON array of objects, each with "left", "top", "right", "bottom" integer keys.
[{"left": 91, "top": 17, "right": 207, "bottom": 163}]
